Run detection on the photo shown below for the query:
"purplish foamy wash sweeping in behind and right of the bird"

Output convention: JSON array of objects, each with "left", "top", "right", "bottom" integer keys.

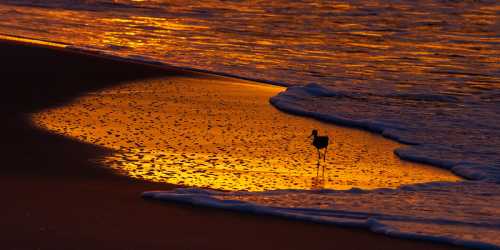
[{"left": 270, "top": 83, "right": 500, "bottom": 182}]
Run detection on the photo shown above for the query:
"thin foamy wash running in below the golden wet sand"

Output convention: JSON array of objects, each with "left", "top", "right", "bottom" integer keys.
[{"left": 142, "top": 182, "right": 500, "bottom": 249}]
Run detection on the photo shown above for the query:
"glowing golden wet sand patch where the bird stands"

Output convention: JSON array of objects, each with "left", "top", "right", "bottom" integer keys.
[{"left": 33, "top": 77, "right": 459, "bottom": 191}]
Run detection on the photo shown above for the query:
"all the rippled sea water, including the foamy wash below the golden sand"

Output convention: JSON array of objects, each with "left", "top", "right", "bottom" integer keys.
[{"left": 0, "top": 0, "right": 500, "bottom": 248}]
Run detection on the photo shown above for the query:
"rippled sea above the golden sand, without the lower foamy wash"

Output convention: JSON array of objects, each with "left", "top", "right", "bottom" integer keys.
[{"left": 0, "top": 0, "right": 500, "bottom": 181}]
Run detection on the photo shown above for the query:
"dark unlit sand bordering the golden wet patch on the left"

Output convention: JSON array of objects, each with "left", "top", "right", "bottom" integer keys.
[{"left": 0, "top": 42, "right": 464, "bottom": 249}]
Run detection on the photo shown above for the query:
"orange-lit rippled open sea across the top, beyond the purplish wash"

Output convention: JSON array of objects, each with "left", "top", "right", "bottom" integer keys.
[{"left": 0, "top": 0, "right": 500, "bottom": 99}]
